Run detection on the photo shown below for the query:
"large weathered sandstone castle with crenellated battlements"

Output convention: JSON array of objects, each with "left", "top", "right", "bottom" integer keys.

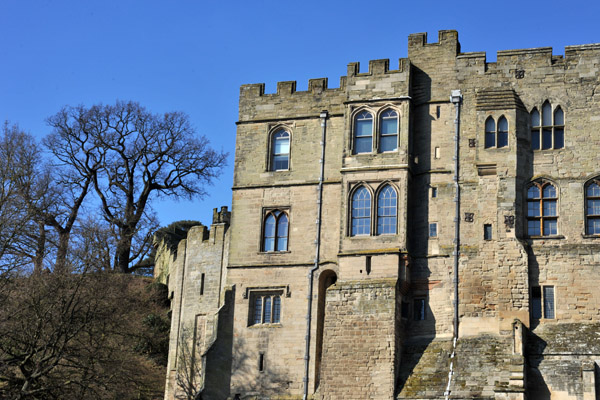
[{"left": 155, "top": 30, "right": 600, "bottom": 400}]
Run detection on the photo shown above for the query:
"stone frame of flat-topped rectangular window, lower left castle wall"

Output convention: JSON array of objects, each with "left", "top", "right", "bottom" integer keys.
[{"left": 246, "top": 287, "right": 289, "bottom": 327}]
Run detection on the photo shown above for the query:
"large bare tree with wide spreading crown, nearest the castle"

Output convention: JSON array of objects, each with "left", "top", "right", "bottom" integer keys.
[{"left": 46, "top": 102, "right": 227, "bottom": 272}]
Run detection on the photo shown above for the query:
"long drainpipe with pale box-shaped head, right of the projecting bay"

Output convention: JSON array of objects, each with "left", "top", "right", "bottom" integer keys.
[{"left": 444, "top": 90, "right": 462, "bottom": 400}]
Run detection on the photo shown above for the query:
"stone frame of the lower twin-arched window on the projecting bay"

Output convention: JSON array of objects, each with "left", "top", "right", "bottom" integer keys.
[{"left": 347, "top": 180, "right": 400, "bottom": 238}]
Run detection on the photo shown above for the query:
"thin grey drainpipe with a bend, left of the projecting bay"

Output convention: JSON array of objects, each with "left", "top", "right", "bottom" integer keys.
[{"left": 302, "top": 110, "right": 327, "bottom": 400}]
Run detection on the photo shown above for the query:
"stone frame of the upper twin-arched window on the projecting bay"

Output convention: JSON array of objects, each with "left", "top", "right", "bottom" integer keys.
[{"left": 350, "top": 104, "right": 402, "bottom": 156}]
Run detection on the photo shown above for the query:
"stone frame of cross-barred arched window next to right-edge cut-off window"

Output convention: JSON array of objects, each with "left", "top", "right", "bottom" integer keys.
[{"left": 525, "top": 178, "right": 560, "bottom": 238}]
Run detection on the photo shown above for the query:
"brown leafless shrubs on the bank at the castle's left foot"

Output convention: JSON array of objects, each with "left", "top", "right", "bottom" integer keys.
[{"left": 0, "top": 272, "right": 170, "bottom": 399}]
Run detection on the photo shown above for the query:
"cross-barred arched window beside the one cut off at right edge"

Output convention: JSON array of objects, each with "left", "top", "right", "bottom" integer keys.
[{"left": 527, "top": 181, "right": 558, "bottom": 236}]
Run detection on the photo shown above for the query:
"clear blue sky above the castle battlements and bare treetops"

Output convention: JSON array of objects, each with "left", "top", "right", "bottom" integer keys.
[{"left": 0, "top": 0, "right": 600, "bottom": 224}]
